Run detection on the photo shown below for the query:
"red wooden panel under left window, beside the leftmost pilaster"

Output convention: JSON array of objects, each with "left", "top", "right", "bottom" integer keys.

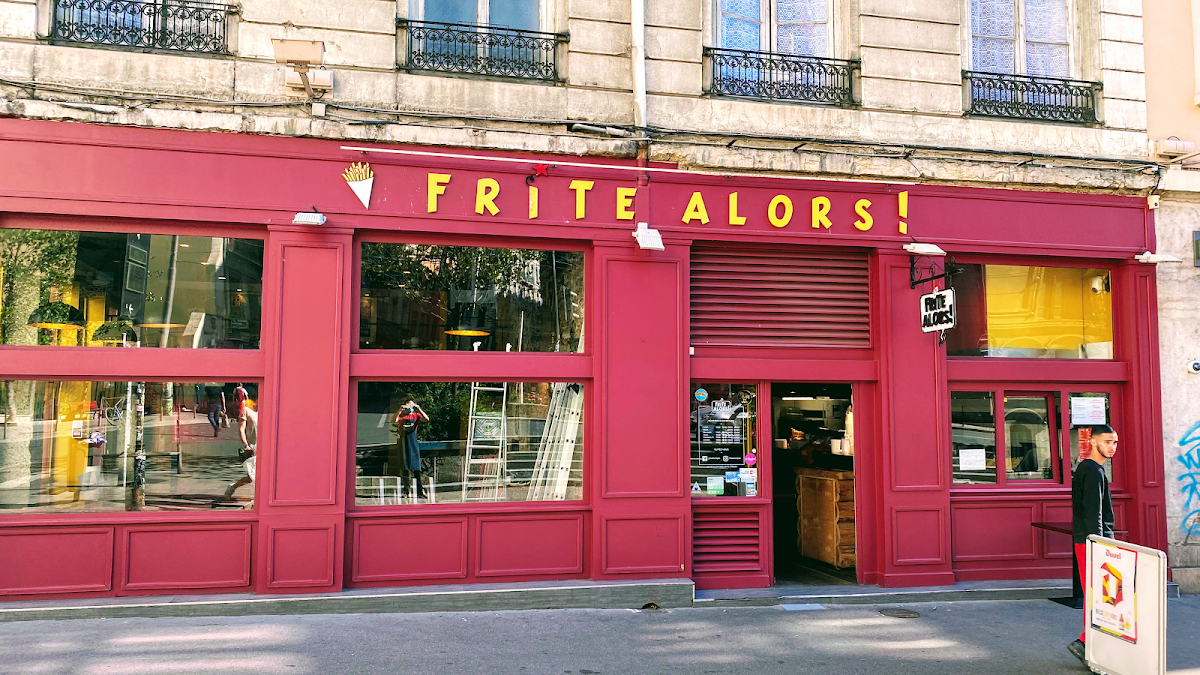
[{"left": 121, "top": 522, "right": 251, "bottom": 590}]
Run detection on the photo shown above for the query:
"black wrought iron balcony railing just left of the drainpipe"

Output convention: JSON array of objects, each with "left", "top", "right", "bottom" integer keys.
[{"left": 398, "top": 19, "right": 569, "bottom": 82}]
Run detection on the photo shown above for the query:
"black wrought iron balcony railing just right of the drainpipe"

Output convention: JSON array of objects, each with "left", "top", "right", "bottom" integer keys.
[{"left": 704, "top": 47, "right": 859, "bottom": 106}]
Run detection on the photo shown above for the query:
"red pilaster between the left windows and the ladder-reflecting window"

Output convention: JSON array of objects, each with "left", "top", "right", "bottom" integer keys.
[{"left": 254, "top": 226, "right": 355, "bottom": 592}]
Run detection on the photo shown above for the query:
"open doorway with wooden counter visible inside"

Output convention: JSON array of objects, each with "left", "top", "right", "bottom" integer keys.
[{"left": 770, "top": 382, "right": 858, "bottom": 586}]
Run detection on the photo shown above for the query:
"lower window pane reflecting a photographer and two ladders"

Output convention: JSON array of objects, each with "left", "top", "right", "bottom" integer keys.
[{"left": 355, "top": 382, "right": 583, "bottom": 506}]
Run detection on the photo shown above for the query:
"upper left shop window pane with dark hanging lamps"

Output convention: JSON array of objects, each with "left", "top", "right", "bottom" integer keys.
[{"left": 0, "top": 229, "right": 263, "bottom": 350}]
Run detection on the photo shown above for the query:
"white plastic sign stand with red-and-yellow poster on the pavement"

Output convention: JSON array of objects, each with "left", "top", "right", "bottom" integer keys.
[{"left": 1084, "top": 534, "right": 1166, "bottom": 675}]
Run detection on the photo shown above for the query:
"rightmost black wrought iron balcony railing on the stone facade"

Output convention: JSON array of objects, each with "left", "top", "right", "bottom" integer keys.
[{"left": 962, "top": 71, "right": 1104, "bottom": 124}]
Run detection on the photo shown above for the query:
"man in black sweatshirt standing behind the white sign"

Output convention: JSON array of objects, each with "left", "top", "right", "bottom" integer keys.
[{"left": 1067, "top": 424, "right": 1117, "bottom": 665}]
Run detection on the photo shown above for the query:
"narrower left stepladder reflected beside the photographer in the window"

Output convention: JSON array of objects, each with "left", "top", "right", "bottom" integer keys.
[{"left": 462, "top": 382, "right": 509, "bottom": 502}]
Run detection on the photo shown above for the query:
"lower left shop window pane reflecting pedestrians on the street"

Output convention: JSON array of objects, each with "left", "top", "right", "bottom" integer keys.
[{"left": 0, "top": 380, "right": 258, "bottom": 512}]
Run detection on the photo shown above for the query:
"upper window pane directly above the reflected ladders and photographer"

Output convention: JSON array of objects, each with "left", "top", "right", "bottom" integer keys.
[{"left": 359, "top": 243, "right": 583, "bottom": 352}]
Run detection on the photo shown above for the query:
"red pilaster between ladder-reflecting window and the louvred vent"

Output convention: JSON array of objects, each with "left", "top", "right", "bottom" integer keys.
[{"left": 588, "top": 239, "right": 691, "bottom": 579}]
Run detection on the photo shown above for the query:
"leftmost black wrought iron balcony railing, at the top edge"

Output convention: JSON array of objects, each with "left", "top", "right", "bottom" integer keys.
[{"left": 50, "top": 0, "right": 238, "bottom": 54}]
